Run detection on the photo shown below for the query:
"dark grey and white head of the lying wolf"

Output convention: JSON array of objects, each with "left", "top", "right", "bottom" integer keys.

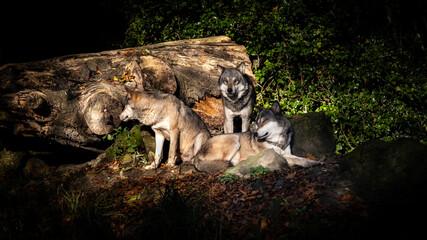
[{"left": 253, "top": 102, "right": 292, "bottom": 145}]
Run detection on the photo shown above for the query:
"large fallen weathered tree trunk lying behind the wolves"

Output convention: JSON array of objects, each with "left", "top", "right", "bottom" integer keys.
[{"left": 0, "top": 36, "right": 253, "bottom": 151}]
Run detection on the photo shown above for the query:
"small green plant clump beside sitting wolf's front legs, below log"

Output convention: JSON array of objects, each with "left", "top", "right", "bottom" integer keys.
[{"left": 102, "top": 126, "right": 147, "bottom": 164}]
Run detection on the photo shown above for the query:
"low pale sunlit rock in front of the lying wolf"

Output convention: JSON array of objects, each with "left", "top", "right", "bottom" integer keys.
[{"left": 224, "top": 149, "right": 287, "bottom": 178}]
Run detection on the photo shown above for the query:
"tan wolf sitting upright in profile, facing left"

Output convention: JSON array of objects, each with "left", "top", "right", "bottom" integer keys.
[{"left": 119, "top": 88, "right": 210, "bottom": 169}]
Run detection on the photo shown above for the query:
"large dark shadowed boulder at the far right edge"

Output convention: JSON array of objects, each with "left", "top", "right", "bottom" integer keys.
[{"left": 340, "top": 138, "right": 427, "bottom": 201}]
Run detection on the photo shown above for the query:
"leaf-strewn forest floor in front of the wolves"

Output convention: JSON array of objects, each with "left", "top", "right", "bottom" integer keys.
[{"left": 0, "top": 153, "right": 424, "bottom": 239}]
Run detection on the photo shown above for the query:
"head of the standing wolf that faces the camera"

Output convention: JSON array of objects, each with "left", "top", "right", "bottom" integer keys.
[{"left": 218, "top": 63, "right": 249, "bottom": 101}]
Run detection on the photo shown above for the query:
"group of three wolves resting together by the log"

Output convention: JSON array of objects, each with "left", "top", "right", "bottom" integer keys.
[{"left": 119, "top": 63, "right": 321, "bottom": 172}]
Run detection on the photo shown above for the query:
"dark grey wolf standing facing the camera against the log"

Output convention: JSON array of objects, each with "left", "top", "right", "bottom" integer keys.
[{"left": 218, "top": 63, "right": 255, "bottom": 133}]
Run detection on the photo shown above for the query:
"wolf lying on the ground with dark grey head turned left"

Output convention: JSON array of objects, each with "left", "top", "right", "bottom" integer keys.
[{"left": 193, "top": 102, "right": 321, "bottom": 172}]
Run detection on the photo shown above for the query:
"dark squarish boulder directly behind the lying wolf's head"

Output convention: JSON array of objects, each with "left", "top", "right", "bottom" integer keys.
[{"left": 289, "top": 112, "right": 336, "bottom": 159}]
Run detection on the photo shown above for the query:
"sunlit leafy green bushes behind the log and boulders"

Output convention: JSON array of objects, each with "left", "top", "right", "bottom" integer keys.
[{"left": 124, "top": 0, "right": 427, "bottom": 154}]
